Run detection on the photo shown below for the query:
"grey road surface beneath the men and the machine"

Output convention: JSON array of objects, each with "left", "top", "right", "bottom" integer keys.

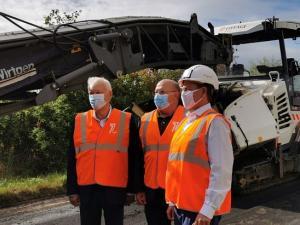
[{"left": 0, "top": 180, "right": 300, "bottom": 225}]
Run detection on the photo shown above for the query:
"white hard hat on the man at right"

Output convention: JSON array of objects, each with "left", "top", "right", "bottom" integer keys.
[{"left": 179, "top": 65, "right": 219, "bottom": 90}]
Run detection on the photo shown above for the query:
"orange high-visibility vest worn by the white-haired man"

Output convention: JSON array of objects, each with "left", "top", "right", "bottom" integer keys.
[{"left": 73, "top": 109, "right": 131, "bottom": 187}]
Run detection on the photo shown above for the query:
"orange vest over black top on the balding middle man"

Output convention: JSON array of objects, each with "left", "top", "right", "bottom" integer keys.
[{"left": 140, "top": 106, "right": 184, "bottom": 189}]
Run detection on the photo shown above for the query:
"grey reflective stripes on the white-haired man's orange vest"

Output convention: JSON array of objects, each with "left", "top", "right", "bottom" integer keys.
[{"left": 75, "top": 112, "right": 127, "bottom": 154}]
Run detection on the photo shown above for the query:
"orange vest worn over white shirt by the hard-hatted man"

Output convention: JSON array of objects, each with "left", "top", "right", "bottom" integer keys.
[{"left": 166, "top": 109, "right": 231, "bottom": 215}]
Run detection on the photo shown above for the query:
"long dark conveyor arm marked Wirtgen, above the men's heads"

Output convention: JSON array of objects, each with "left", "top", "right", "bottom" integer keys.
[{"left": 0, "top": 13, "right": 232, "bottom": 115}]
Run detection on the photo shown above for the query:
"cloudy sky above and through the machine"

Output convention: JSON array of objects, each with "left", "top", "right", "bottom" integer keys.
[{"left": 0, "top": 0, "right": 300, "bottom": 68}]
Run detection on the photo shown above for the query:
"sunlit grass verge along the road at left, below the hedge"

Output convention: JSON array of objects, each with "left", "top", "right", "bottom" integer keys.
[{"left": 0, "top": 173, "right": 66, "bottom": 208}]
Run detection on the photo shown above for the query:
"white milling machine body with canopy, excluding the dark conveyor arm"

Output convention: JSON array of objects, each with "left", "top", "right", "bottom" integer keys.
[{"left": 213, "top": 17, "right": 300, "bottom": 192}]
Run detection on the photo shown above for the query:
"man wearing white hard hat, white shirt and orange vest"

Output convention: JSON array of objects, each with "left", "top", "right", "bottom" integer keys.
[{"left": 166, "top": 65, "right": 233, "bottom": 225}]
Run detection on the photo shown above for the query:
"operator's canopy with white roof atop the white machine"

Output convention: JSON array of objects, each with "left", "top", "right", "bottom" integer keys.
[{"left": 215, "top": 17, "right": 300, "bottom": 110}]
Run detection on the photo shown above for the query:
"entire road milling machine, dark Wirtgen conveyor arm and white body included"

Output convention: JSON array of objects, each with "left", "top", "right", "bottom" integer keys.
[{"left": 0, "top": 13, "right": 300, "bottom": 192}]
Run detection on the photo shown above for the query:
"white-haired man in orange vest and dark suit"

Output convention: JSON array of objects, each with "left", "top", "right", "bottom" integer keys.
[{"left": 67, "top": 77, "right": 143, "bottom": 225}]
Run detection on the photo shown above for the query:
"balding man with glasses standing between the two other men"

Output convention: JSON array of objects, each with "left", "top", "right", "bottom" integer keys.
[{"left": 136, "top": 79, "right": 184, "bottom": 225}]
